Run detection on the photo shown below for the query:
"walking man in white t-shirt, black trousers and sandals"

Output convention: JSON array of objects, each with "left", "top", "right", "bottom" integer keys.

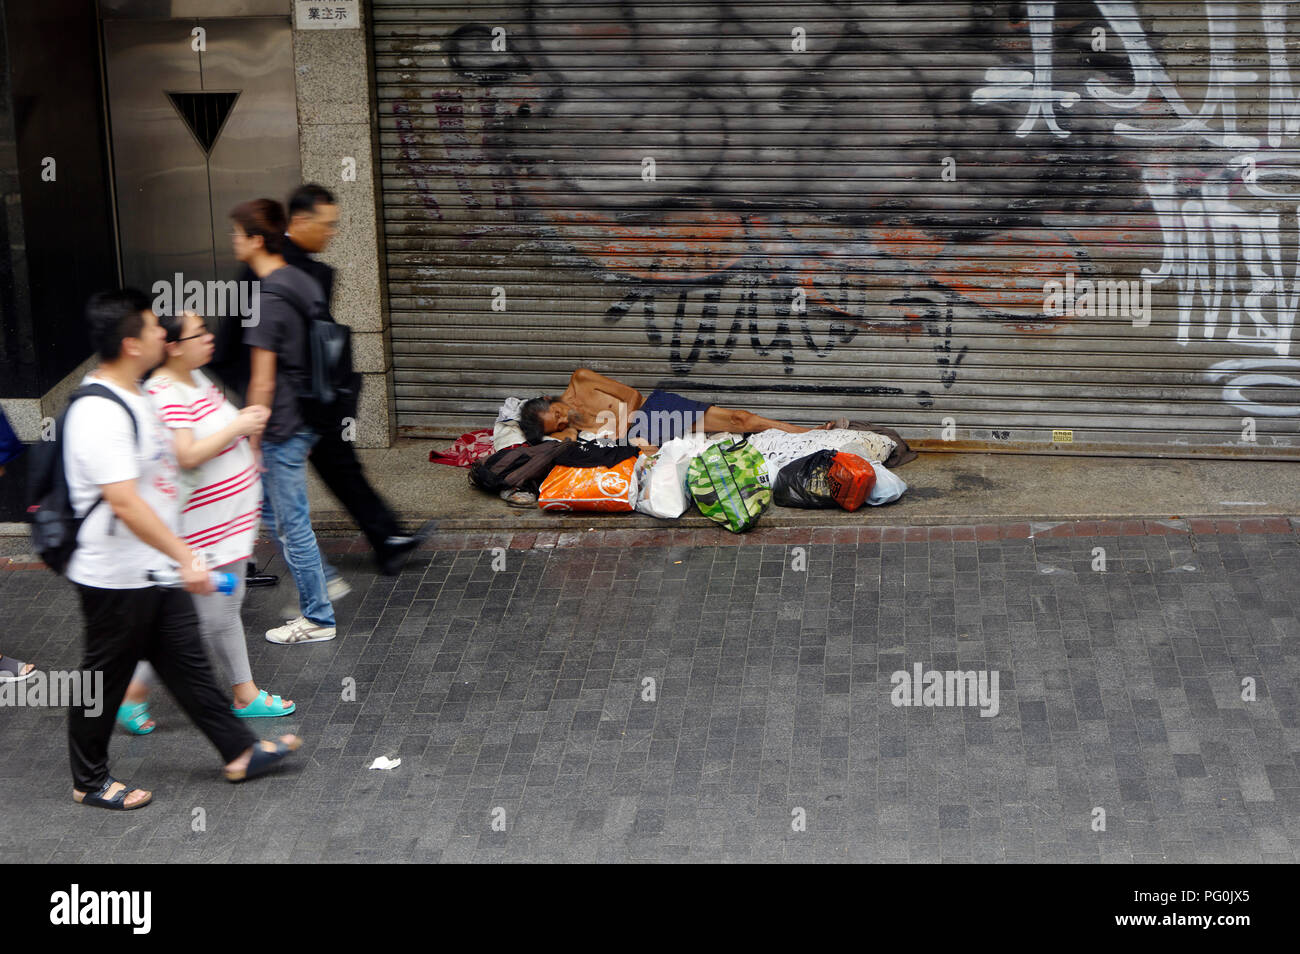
[{"left": 62, "top": 290, "right": 302, "bottom": 811}]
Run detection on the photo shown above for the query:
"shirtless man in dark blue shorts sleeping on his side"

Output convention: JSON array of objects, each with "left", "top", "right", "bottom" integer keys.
[{"left": 519, "top": 368, "right": 848, "bottom": 447}]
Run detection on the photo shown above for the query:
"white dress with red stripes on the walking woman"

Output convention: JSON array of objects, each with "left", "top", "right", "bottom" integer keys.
[{"left": 144, "top": 370, "right": 261, "bottom": 567}]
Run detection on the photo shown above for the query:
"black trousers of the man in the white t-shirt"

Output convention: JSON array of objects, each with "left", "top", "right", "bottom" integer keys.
[{"left": 68, "top": 584, "right": 257, "bottom": 792}]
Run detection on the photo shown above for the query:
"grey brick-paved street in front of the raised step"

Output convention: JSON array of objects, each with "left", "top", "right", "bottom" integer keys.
[{"left": 0, "top": 520, "right": 1300, "bottom": 862}]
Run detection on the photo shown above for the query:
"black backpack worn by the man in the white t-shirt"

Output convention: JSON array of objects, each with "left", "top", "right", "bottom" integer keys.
[{"left": 27, "top": 385, "right": 140, "bottom": 576}]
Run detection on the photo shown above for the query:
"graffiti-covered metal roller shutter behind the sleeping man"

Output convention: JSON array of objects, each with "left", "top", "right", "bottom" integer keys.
[{"left": 371, "top": 0, "right": 1300, "bottom": 456}]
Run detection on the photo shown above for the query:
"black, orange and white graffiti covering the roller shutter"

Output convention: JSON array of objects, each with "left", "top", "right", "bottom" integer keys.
[{"left": 379, "top": 0, "right": 1300, "bottom": 434}]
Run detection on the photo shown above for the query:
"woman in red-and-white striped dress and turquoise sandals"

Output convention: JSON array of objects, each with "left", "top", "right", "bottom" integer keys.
[{"left": 117, "top": 312, "right": 295, "bottom": 736}]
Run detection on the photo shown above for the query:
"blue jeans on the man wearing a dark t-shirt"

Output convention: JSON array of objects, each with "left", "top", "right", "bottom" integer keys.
[{"left": 261, "top": 428, "right": 338, "bottom": 626}]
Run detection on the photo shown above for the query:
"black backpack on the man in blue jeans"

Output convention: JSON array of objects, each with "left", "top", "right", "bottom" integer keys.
[{"left": 261, "top": 273, "right": 361, "bottom": 434}]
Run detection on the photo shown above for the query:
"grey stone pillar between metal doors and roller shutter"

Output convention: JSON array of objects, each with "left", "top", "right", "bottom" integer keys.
[{"left": 294, "top": 3, "right": 397, "bottom": 447}]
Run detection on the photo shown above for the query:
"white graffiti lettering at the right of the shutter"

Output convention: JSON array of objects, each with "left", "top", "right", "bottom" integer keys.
[{"left": 972, "top": 0, "right": 1300, "bottom": 416}]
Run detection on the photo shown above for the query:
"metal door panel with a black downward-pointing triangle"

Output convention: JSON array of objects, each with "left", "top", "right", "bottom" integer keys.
[{"left": 104, "top": 18, "right": 300, "bottom": 291}]
